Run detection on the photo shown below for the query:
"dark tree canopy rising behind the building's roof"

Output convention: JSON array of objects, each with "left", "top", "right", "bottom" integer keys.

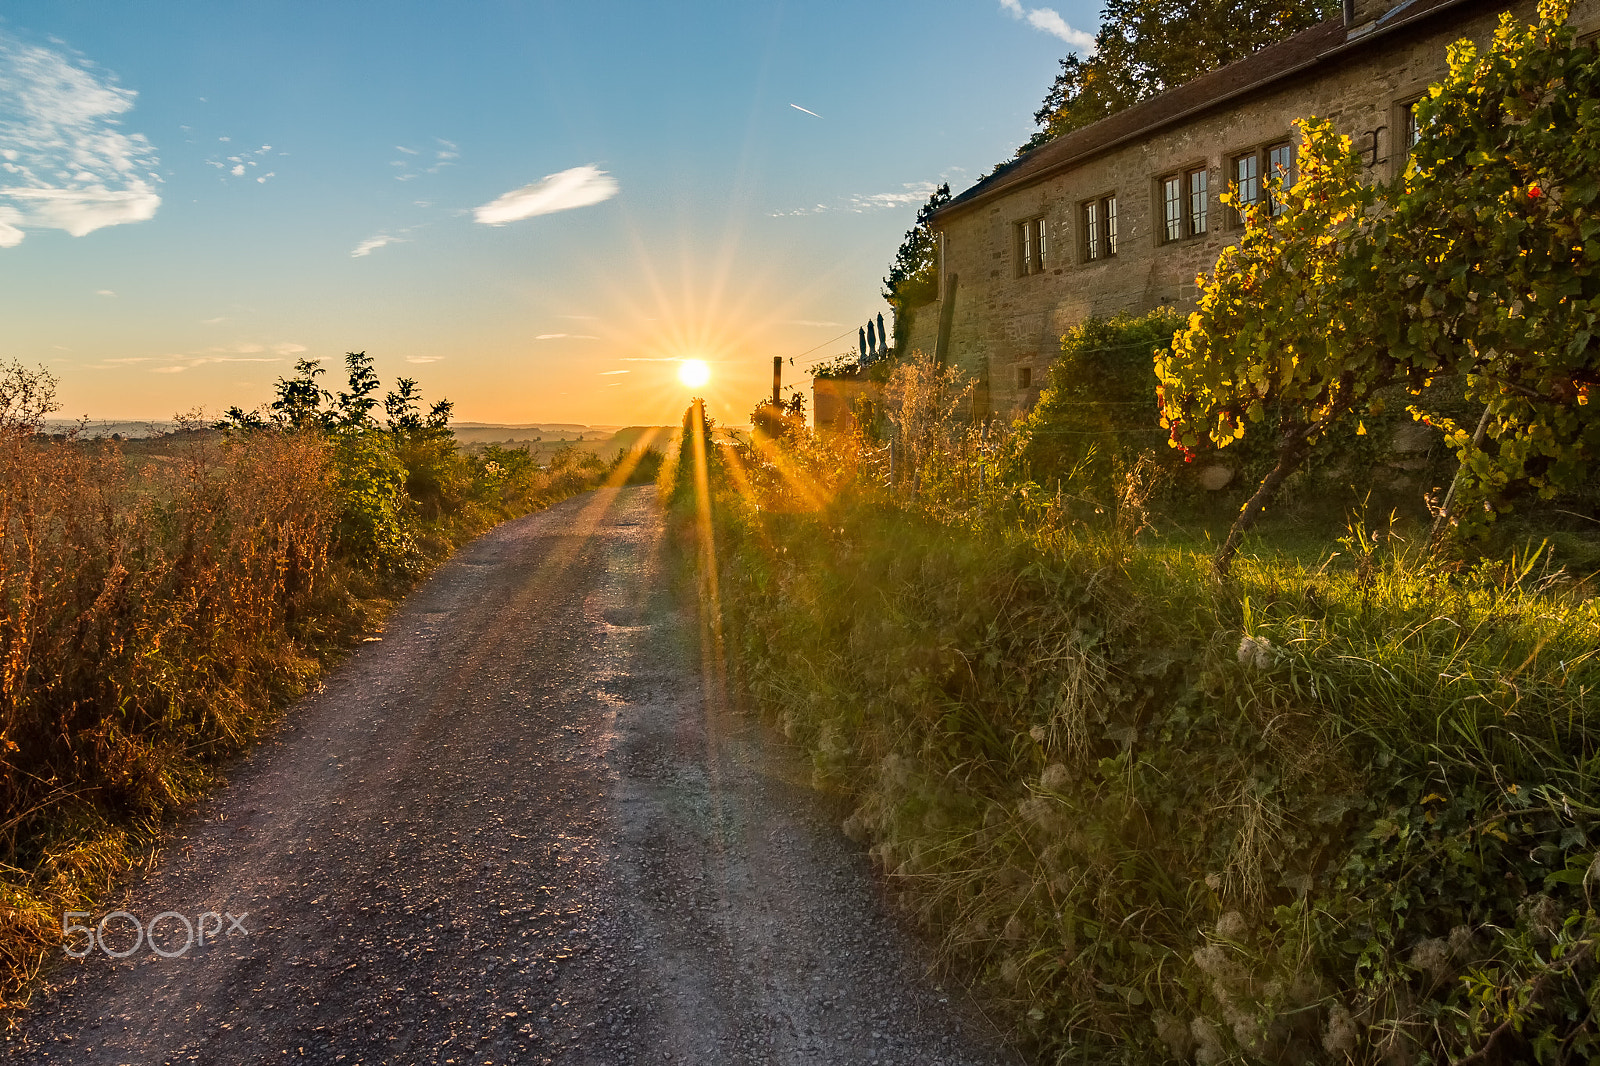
[{"left": 1021, "top": 0, "right": 1339, "bottom": 152}]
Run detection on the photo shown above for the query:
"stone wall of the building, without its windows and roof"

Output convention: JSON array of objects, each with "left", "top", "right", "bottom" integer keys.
[{"left": 914, "top": 0, "right": 1600, "bottom": 418}]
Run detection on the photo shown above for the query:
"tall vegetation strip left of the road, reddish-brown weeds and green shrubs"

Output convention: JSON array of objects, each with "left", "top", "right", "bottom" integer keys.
[{"left": 0, "top": 365, "right": 606, "bottom": 1007}]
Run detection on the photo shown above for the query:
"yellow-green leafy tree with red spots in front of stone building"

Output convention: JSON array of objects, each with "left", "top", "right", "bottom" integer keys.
[{"left": 1157, "top": 0, "right": 1600, "bottom": 571}]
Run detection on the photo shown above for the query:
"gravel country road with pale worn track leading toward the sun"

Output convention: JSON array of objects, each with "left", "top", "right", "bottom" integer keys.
[{"left": 5, "top": 488, "right": 1018, "bottom": 1066}]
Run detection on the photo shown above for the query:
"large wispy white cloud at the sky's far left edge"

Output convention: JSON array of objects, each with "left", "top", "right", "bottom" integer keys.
[{"left": 0, "top": 32, "right": 162, "bottom": 248}]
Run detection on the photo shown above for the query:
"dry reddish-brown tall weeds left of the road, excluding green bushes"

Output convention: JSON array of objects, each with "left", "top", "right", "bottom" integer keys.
[{"left": 0, "top": 426, "right": 336, "bottom": 994}]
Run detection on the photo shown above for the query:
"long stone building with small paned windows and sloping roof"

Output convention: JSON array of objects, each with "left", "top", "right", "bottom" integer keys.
[{"left": 909, "top": 0, "right": 1600, "bottom": 418}]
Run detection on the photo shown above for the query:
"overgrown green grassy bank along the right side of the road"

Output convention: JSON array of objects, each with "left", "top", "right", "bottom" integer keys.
[{"left": 681, "top": 350, "right": 1600, "bottom": 1063}]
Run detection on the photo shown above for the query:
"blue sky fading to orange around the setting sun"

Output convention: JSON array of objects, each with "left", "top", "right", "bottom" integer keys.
[{"left": 0, "top": 0, "right": 1098, "bottom": 424}]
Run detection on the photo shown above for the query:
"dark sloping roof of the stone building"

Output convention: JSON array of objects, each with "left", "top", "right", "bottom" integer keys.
[{"left": 933, "top": 0, "right": 1469, "bottom": 227}]
